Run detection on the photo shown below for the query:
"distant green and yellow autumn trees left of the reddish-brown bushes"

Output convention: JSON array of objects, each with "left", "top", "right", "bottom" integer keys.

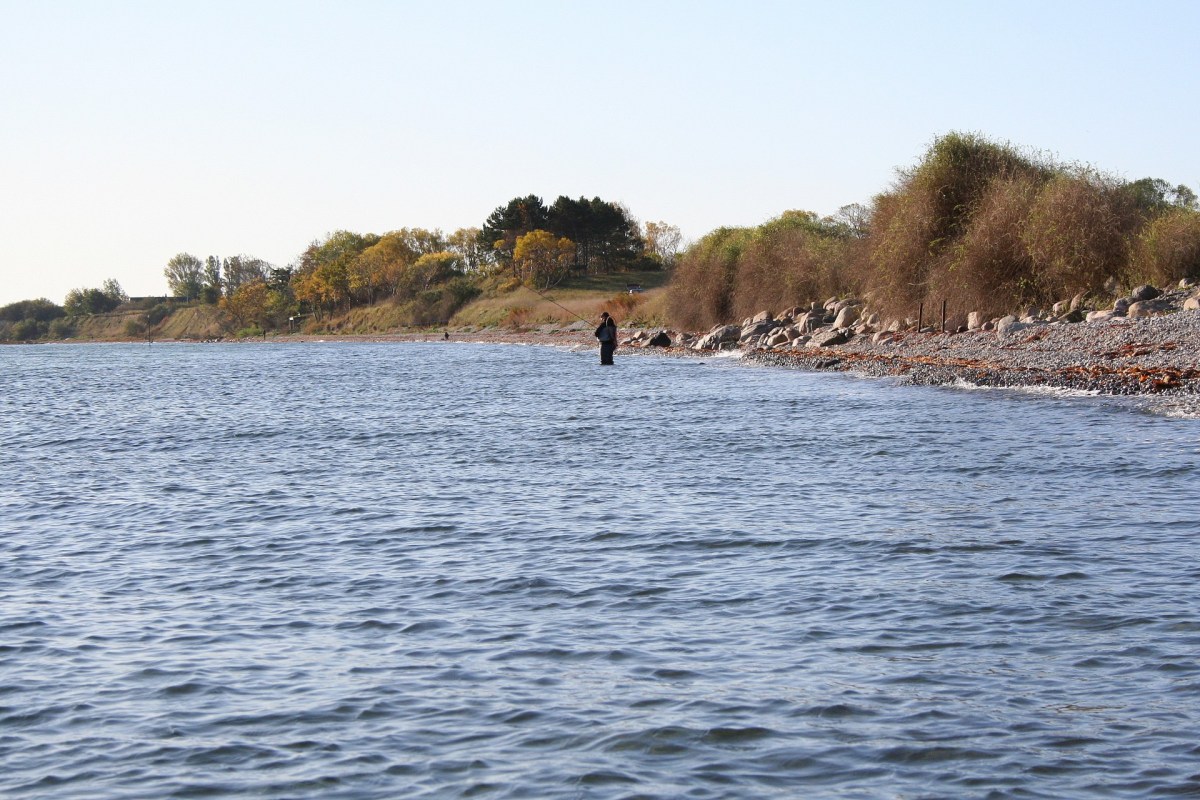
[{"left": 0, "top": 194, "right": 682, "bottom": 341}]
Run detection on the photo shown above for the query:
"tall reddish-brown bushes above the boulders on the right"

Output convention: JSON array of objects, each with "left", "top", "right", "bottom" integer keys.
[{"left": 667, "top": 133, "right": 1200, "bottom": 329}]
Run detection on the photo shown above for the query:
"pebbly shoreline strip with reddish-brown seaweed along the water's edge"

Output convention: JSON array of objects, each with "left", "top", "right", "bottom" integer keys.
[{"left": 16, "top": 311, "right": 1200, "bottom": 416}]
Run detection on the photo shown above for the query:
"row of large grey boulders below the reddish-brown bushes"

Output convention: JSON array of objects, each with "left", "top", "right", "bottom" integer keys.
[{"left": 626, "top": 279, "right": 1200, "bottom": 350}]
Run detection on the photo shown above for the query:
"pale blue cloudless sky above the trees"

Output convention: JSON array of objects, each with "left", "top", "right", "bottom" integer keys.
[{"left": 0, "top": 0, "right": 1200, "bottom": 305}]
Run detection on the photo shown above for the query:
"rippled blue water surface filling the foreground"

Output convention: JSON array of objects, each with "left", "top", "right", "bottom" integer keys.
[{"left": 0, "top": 343, "right": 1200, "bottom": 799}]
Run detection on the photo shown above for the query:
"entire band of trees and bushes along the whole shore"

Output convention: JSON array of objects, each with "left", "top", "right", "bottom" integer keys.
[{"left": 9, "top": 133, "right": 1200, "bottom": 339}]
